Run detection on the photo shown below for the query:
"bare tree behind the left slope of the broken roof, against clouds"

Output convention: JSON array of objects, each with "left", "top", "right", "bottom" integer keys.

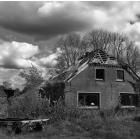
[{"left": 56, "top": 33, "right": 85, "bottom": 71}]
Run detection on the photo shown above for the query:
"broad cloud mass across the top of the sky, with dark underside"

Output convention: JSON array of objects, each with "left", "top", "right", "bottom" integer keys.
[{"left": 0, "top": 1, "right": 140, "bottom": 40}]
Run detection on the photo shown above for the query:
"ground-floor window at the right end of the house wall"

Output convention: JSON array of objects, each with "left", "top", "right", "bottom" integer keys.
[{"left": 120, "top": 93, "right": 138, "bottom": 106}]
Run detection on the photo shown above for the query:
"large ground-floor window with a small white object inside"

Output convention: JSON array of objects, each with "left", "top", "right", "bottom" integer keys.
[{"left": 78, "top": 93, "right": 100, "bottom": 108}]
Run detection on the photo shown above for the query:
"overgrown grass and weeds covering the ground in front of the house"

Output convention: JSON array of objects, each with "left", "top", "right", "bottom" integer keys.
[{"left": 2, "top": 99, "right": 140, "bottom": 138}]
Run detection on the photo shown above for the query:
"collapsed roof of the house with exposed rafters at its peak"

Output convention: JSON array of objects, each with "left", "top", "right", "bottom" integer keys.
[{"left": 53, "top": 49, "right": 140, "bottom": 82}]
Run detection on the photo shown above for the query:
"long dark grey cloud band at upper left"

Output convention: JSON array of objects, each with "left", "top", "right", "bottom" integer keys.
[{"left": 0, "top": 18, "right": 89, "bottom": 38}]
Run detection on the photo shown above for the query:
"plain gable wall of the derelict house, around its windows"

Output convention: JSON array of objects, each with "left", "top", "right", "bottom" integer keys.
[{"left": 65, "top": 66, "right": 135, "bottom": 109}]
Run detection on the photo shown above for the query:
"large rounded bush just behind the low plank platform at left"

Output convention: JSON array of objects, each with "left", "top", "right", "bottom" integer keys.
[{"left": 8, "top": 90, "right": 49, "bottom": 118}]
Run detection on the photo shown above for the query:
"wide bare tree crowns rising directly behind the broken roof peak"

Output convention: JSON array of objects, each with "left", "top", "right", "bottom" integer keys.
[{"left": 82, "top": 29, "right": 127, "bottom": 58}]
